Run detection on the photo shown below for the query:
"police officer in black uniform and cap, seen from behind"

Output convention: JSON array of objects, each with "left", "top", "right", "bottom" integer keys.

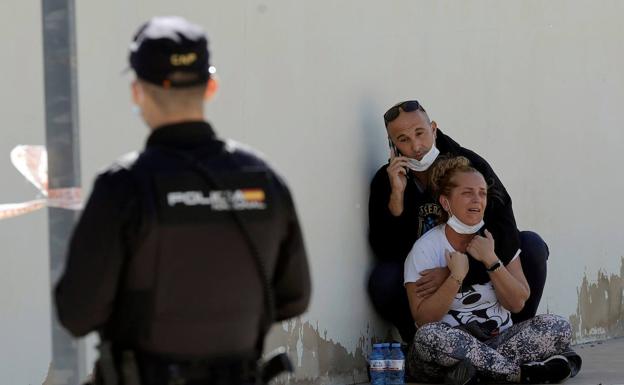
[{"left": 55, "top": 17, "right": 310, "bottom": 385}]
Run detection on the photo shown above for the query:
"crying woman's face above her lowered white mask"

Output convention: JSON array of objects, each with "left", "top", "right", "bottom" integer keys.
[{"left": 440, "top": 172, "right": 487, "bottom": 226}]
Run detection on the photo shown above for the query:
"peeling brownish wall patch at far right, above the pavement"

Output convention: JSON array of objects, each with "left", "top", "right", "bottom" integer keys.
[{"left": 570, "top": 257, "right": 624, "bottom": 343}]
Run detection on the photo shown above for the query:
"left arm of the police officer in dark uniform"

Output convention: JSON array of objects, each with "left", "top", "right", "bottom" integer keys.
[{"left": 55, "top": 174, "right": 132, "bottom": 336}]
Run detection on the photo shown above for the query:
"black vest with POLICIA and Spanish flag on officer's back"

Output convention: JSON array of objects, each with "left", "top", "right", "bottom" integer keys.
[{"left": 103, "top": 141, "right": 284, "bottom": 359}]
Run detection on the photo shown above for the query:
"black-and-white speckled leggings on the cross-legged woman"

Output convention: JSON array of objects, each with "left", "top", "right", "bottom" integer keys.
[{"left": 406, "top": 314, "right": 572, "bottom": 382}]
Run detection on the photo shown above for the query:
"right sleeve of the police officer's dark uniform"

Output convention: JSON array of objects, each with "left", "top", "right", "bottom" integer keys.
[{"left": 273, "top": 178, "right": 311, "bottom": 321}]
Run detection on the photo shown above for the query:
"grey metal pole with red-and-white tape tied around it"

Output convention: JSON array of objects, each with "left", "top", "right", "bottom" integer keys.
[{"left": 41, "top": 0, "right": 86, "bottom": 385}]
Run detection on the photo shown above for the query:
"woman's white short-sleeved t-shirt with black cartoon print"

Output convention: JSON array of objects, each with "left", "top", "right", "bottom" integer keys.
[{"left": 404, "top": 224, "right": 519, "bottom": 331}]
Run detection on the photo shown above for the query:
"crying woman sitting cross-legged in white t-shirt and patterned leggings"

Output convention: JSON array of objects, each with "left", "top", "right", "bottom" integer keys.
[{"left": 404, "top": 157, "right": 581, "bottom": 385}]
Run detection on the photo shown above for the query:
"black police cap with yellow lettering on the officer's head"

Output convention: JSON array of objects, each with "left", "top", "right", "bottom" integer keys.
[{"left": 130, "top": 16, "right": 214, "bottom": 88}]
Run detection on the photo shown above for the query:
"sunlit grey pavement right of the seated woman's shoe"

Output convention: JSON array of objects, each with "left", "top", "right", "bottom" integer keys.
[{"left": 404, "top": 338, "right": 624, "bottom": 385}]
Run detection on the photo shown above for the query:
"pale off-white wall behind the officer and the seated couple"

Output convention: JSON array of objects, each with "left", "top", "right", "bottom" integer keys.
[{"left": 0, "top": 0, "right": 624, "bottom": 384}]
